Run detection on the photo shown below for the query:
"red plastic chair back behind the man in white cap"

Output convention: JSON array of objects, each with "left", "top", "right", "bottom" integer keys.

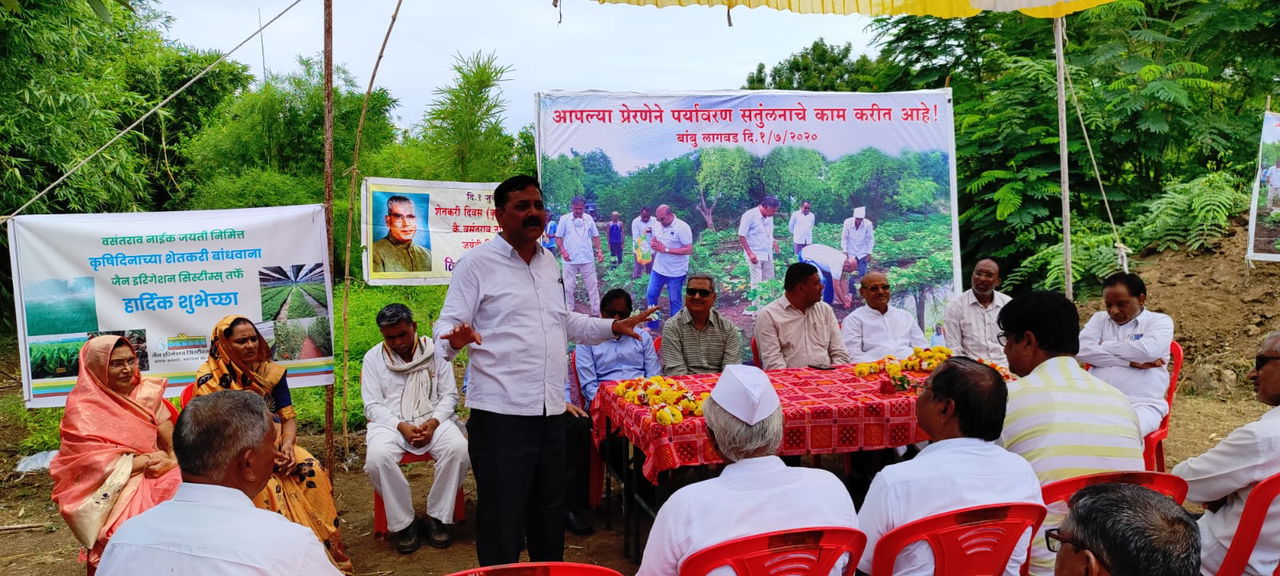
[{"left": 680, "top": 526, "right": 867, "bottom": 576}]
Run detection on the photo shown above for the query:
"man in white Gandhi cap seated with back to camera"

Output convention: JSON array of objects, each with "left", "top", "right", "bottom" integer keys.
[{"left": 636, "top": 365, "right": 858, "bottom": 576}]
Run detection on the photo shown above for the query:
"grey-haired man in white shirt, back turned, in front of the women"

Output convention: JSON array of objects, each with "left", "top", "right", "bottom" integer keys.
[{"left": 97, "top": 392, "right": 339, "bottom": 576}]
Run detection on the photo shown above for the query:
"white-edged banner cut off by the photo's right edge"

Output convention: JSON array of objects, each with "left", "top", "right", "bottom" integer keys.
[{"left": 1249, "top": 113, "right": 1280, "bottom": 261}]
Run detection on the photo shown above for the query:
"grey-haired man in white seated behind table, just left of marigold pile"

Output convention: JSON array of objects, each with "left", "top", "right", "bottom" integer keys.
[{"left": 840, "top": 271, "right": 927, "bottom": 364}]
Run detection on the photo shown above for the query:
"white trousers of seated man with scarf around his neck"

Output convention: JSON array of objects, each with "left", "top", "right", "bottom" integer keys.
[{"left": 365, "top": 420, "right": 471, "bottom": 531}]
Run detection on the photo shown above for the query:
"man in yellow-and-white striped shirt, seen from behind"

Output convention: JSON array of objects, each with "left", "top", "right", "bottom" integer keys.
[{"left": 997, "top": 292, "right": 1143, "bottom": 576}]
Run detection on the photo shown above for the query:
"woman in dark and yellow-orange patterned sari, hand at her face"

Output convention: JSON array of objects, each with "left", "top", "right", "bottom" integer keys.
[{"left": 195, "top": 315, "right": 352, "bottom": 573}]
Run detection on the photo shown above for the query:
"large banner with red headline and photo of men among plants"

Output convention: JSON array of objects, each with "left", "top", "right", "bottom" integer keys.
[{"left": 538, "top": 90, "right": 960, "bottom": 334}]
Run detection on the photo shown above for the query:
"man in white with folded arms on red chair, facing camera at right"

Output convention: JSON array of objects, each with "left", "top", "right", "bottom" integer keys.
[{"left": 1075, "top": 273, "right": 1174, "bottom": 436}]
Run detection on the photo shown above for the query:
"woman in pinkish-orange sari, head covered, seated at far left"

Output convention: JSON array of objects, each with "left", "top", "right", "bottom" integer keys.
[{"left": 49, "top": 335, "right": 182, "bottom": 575}]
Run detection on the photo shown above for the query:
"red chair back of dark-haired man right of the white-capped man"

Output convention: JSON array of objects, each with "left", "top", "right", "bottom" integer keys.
[{"left": 872, "top": 502, "right": 1046, "bottom": 576}]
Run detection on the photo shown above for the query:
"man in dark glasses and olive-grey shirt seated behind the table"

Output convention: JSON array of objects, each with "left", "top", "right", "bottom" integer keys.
[{"left": 662, "top": 274, "right": 742, "bottom": 376}]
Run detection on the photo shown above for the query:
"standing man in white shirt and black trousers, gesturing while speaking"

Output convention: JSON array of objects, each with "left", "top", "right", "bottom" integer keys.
[{"left": 434, "top": 175, "right": 653, "bottom": 566}]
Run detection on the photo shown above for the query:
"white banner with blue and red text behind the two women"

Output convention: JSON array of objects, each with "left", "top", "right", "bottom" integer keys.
[{"left": 9, "top": 205, "right": 333, "bottom": 408}]
